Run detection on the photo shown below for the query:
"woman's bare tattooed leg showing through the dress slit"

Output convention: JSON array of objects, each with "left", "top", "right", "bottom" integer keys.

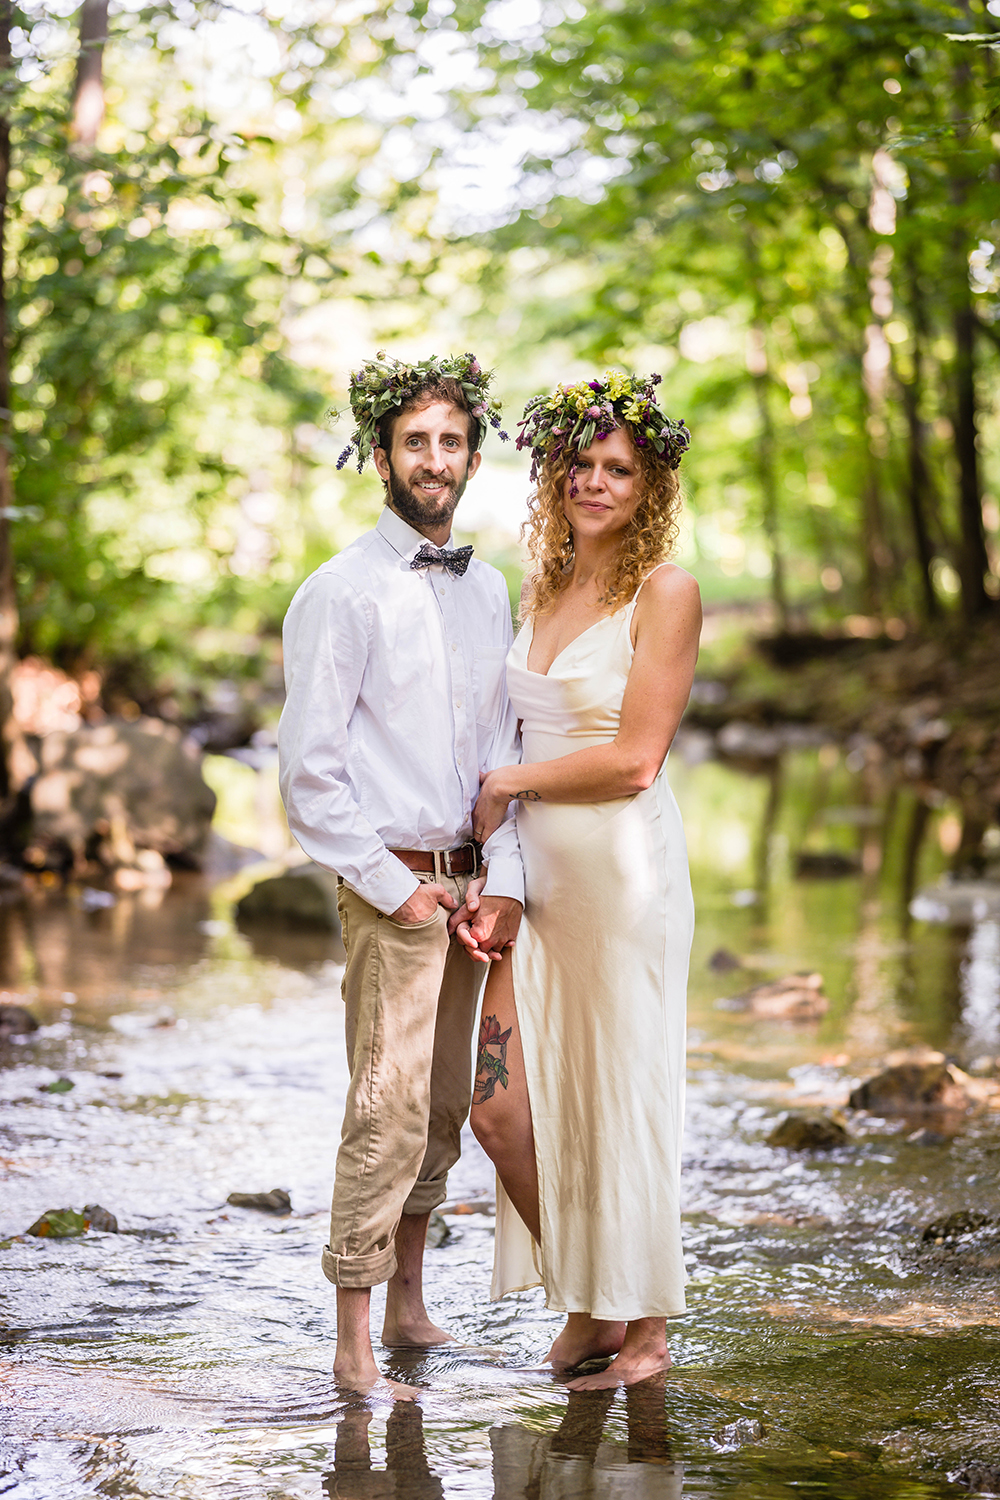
[{"left": 471, "top": 950, "right": 541, "bottom": 1241}]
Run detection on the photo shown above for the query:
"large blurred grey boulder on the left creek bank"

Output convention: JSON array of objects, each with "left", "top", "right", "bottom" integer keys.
[{"left": 31, "top": 719, "right": 216, "bottom": 867}]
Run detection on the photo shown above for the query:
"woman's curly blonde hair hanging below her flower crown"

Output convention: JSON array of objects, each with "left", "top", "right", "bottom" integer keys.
[{"left": 520, "top": 435, "right": 681, "bottom": 620}]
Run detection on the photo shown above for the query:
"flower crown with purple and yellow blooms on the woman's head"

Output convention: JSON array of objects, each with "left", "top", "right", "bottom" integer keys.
[{"left": 517, "top": 371, "right": 691, "bottom": 483}]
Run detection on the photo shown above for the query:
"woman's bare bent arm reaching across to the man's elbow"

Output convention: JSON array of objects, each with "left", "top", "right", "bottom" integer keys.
[{"left": 472, "top": 567, "right": 702, "bottom": 840}]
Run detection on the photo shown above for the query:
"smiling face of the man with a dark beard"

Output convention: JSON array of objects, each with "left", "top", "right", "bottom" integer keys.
[{"left": 375, "top": 401, "right": 481, "bottom": 534}]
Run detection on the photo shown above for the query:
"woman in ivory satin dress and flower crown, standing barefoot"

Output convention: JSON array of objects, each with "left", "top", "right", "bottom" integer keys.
[{"left": 472, "top": 372, "right": 702, "bottom": 1391}]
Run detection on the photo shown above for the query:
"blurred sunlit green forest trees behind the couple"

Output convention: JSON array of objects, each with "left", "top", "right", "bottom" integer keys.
[{"left": 0, "top": 0, "right": 1000, "bottom": 816}]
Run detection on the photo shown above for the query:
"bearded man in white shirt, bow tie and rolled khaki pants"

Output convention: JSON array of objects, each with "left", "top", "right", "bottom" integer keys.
[{"left": 279, "top": 354, "right": 523, "bottom": 1394}]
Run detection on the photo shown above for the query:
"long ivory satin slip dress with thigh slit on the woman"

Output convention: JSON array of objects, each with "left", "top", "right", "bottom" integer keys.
[{"left": 492, "top": 579, "right": 694, "bottom": 1320}]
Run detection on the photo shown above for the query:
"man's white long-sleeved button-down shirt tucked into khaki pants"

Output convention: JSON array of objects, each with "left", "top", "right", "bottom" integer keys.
[{"left": 277, "top": 507, "right": 525, "bottom": 912}]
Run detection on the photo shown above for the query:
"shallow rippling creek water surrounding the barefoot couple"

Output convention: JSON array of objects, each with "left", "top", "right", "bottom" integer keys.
[{"left": 0, "top": 735, "right": 1000, "bottom": 1500}]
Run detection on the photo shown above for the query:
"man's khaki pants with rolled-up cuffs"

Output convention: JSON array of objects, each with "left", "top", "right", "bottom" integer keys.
[{"left": 322, "top": 875, "right": 484, "bottom": 1287}]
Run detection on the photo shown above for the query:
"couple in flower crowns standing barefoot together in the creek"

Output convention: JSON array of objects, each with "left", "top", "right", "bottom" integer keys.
[{"left": 279, "top": 345, "right": 700, "bottom": 1398}]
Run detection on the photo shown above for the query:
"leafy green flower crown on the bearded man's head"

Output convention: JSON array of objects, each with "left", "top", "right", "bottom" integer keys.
[{"left": 334, "top": 350, "right": 507, "bottom": 474}]
